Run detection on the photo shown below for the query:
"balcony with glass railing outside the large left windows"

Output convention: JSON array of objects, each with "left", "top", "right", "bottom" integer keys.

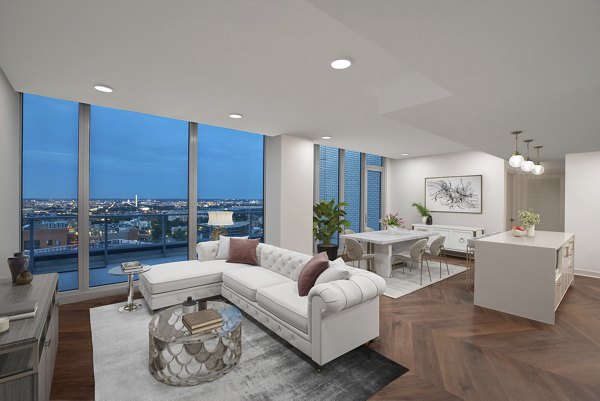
[{"left": 23, "top": 208, "right": 263, "bottom": 291}]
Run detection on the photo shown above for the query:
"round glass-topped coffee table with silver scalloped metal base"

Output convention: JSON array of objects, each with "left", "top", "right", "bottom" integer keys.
[{"left": 148, "top": 301, "right": 242, "bottom": 386}]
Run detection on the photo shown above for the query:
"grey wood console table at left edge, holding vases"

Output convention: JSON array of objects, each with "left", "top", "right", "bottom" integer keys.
[{"left": 0, "top": 273, "right": 58, "bottom": 401}]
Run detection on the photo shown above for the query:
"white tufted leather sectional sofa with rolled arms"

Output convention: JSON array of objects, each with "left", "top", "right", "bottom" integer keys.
[{"left": 140, "top": 241, "right": 385, "bottom": 365}]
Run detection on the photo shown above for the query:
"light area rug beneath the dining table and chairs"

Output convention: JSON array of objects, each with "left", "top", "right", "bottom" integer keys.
[{"left": 383, "top": 261, "right": 467, "bottom": 298}]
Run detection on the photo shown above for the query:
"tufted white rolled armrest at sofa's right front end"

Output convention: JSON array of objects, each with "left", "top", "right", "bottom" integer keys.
[{"left": 308, "top": 269, "right": 385, "bottom": 316}]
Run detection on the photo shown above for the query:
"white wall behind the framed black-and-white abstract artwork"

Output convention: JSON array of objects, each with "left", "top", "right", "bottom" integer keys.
[{"left": 386, "top": 152, "right": 506, "bottom": 233}]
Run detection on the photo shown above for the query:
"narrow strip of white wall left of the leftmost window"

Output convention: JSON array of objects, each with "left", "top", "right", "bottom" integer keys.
[{"left": 0, "top": 70, "right": 21, "bottom": 278}]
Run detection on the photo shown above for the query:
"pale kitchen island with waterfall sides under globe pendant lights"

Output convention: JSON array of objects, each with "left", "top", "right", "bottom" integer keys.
[{"left": 474, "top": 231, "right": 575, "bottom": 324}]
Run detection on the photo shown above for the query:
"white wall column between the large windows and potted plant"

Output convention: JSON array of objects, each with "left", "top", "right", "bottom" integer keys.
[{"left": 265, "top": 135, "right": 314, "bottom": 255}]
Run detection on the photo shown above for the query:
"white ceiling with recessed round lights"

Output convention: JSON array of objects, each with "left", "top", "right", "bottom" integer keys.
[{"left": 0, "top": 0, "right": 600, "bottom": 160}]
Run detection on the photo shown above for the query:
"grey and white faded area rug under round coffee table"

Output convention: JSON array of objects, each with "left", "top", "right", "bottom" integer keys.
[{"left": 90, "top": 301, "right": 408, "bottom": 401}]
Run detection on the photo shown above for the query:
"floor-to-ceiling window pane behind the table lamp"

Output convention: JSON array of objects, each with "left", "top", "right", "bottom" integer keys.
[{"left": 198, "top": 124, "right": 264, "bottom": 241}]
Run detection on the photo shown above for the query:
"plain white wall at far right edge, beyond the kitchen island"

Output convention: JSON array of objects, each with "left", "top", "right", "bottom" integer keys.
[{"left": 565, "top": 152, "right": 600, "bottom": 277}]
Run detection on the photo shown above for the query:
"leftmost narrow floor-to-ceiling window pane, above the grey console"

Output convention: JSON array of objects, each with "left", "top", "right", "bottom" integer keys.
[{"left": 22, "top": 94, "right": 79, "bottom": 291}]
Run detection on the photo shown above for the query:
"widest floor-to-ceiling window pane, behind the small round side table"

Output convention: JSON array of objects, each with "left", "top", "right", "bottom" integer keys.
[{"left": 89, "top": 106, "right": 188, "bottom": 287}]
